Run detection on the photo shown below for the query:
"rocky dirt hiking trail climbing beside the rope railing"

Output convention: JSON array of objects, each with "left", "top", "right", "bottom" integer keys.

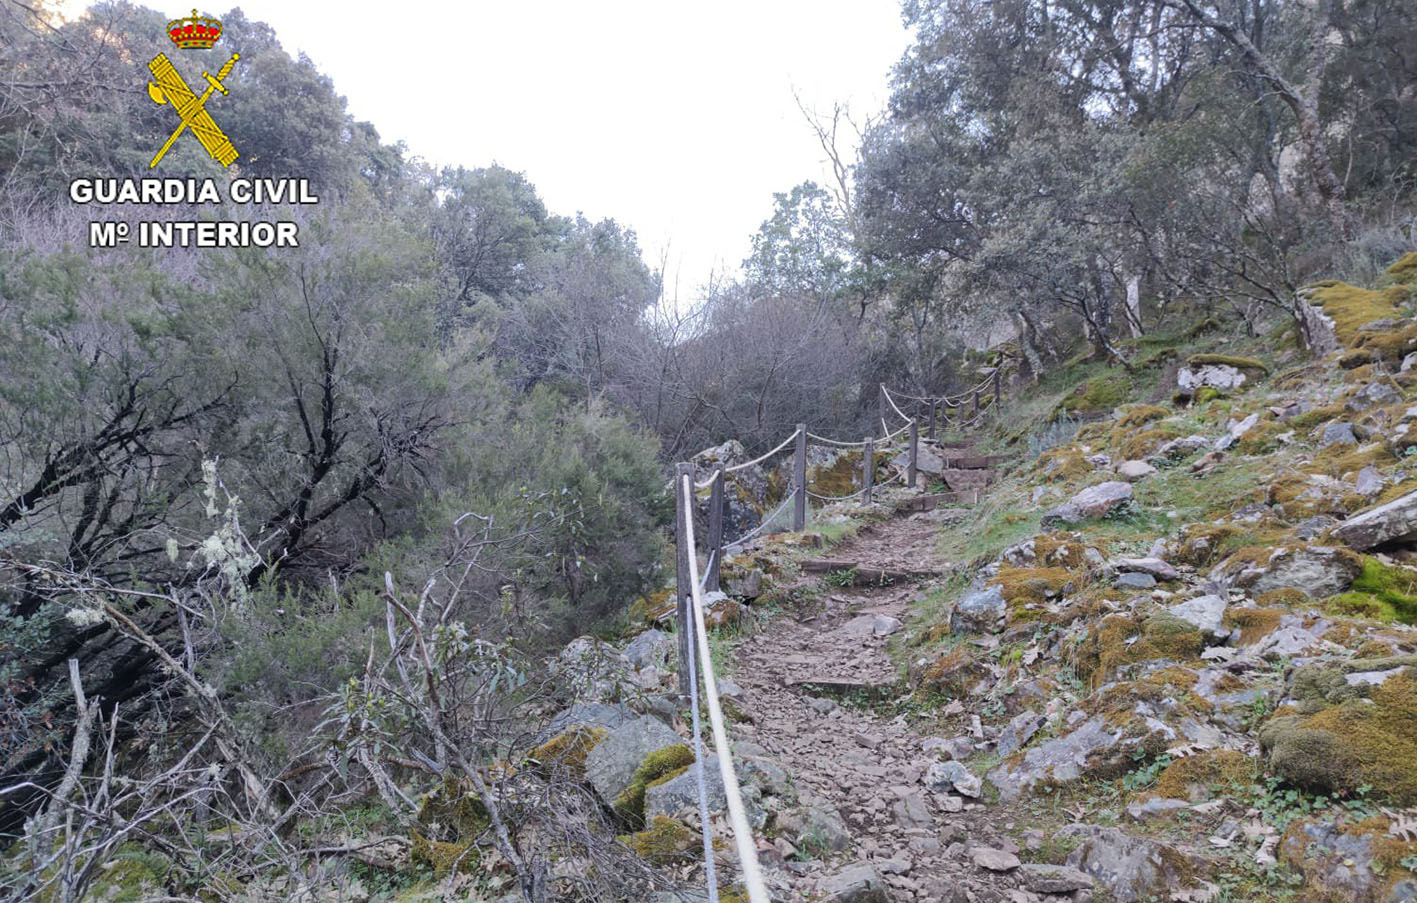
[{"left": 728, "top": 476, "right": 1093, "bottom": 903}]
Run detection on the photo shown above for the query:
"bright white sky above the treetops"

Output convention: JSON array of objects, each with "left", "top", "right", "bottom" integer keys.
[{"left": 64, "top": 0, "right": 908, "bottom": 296}]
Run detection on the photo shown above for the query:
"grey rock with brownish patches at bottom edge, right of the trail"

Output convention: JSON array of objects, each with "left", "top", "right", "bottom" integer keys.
[{"left": 1054, "top": 825, "right": 1195, "bottom": 903}]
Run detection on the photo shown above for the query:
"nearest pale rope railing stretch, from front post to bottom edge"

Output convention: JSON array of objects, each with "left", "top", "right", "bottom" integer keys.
[{"left": 677, "top": 472, "right": 771, "bottom": 903}]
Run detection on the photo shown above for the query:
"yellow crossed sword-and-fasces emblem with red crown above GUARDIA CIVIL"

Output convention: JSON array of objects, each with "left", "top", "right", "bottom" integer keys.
[{"left": 147, "top": 10, "right": 241, "bottom": 169}]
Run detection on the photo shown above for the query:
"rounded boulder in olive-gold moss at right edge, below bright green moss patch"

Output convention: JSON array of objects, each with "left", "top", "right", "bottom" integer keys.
[{"left": 1260, "top": 668, "right": 1417, "bottom": 805}]
